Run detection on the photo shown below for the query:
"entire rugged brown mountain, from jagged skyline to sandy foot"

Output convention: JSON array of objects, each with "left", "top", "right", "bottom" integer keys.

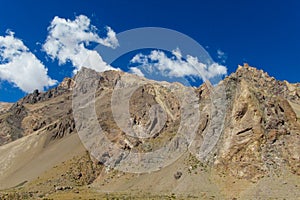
[{"left": 0, "top": 64, "right": 300, "bottom": 199}]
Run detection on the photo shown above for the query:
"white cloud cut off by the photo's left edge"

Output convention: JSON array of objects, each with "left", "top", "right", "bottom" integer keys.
[{"left": 0, "top": 31, "right": 57, "bottom": 93}]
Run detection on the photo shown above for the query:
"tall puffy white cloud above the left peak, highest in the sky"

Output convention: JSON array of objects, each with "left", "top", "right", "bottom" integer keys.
[{"left": 43, "top": 15, "right": 119, "bottom": 72}]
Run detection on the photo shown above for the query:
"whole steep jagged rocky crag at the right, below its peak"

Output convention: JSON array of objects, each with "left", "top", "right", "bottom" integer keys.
[{"left": 214, "top": 65, "right": 300, "bottom": 181}]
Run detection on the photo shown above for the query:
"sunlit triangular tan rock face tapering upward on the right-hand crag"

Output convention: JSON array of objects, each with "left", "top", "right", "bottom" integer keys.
[{"left": 215, "top": 80, "right": 264, "bottom": 181}]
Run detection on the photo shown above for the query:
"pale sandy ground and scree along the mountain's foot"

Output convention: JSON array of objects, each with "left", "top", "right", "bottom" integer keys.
[{"left": 19, "top": 153, "right": 300, "bottom": 200}]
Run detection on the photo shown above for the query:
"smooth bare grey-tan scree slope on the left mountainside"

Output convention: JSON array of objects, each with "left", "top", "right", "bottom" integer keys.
[{"left": 0, "top": 129, "right": 85, "bottom": 189}]
